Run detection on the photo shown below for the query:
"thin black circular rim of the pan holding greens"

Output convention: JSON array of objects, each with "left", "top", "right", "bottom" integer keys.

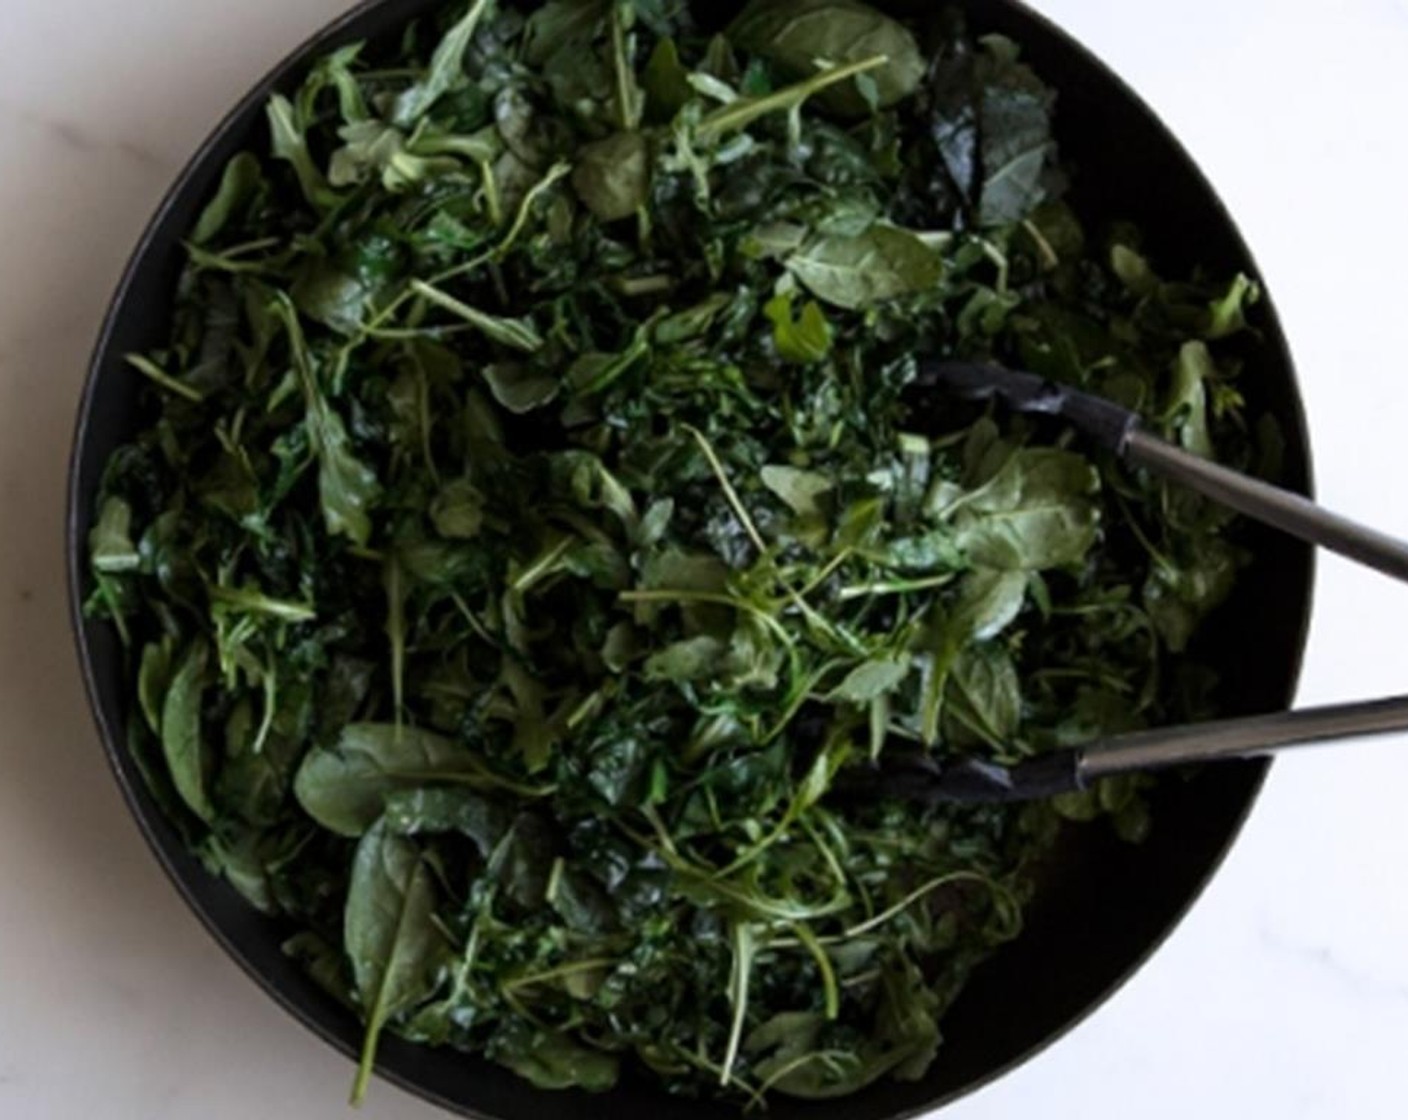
[{"left": 63, "top": 0, "right": 1318, "bottom": 1120}]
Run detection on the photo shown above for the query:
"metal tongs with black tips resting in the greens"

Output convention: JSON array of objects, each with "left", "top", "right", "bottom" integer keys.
[{"left": 860, "top": 361, "right": 1408, "bottom": 803}]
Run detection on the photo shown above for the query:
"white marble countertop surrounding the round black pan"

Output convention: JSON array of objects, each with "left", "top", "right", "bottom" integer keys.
[{"left": 0, "top": 0, "right": 1408, "bottom": 1120}]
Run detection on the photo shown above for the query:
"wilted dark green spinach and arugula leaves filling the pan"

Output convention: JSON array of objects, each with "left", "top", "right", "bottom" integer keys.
[{"left": 90, "top": 0, "right": 1256, "bottom": 1103}]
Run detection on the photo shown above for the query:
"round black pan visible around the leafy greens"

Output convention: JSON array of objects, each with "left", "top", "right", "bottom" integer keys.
[{"left": 68, "top": 0, "right": 1312, "bottom": 1120}]
